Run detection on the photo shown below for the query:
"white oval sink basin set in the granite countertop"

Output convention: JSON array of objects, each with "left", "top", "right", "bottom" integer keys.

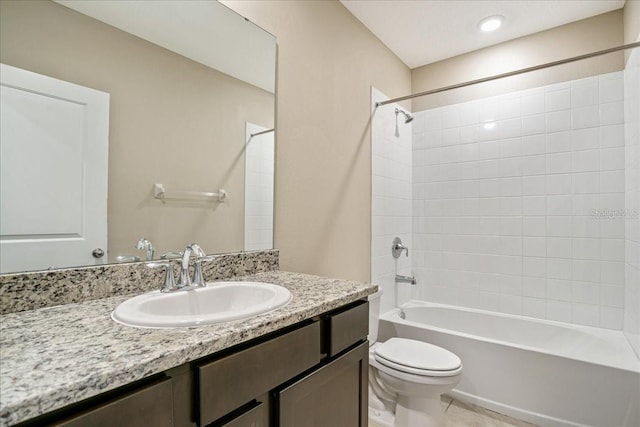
[{"left": 111, "top": 282, "right": 291, "bottom": 328}]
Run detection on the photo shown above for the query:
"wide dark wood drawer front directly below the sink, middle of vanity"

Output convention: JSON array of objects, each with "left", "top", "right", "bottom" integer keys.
[{"left": 195, "top": 322, "right": 321, "bottom": 426}]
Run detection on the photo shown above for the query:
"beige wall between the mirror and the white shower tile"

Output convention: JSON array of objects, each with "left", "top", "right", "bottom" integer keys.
[{"left": 224, "top": 1, "right": 411, "bottom": 280}]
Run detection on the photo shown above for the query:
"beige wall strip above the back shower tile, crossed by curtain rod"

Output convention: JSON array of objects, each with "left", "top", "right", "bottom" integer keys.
[{"left": 411, "top": 9, "right": 624, "bottom": 111}]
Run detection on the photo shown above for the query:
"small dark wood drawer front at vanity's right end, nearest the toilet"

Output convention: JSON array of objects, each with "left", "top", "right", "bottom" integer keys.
[{"left": 326, "top": 301, "right": 369, "bottom": 357}]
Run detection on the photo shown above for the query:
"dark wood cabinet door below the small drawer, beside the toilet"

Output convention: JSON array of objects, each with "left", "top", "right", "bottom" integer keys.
[{"left": 277, "top": 341, "right": 369, "bottom": 427}]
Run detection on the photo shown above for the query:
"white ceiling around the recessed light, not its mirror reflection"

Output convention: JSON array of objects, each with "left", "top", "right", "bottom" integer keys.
[{"left": 340, "top": 0, "right": 624, "bottom": 68}]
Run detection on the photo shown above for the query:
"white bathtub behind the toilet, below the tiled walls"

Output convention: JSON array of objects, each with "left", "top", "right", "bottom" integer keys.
[{"left": 378, "top": 301, "right": 640, "bottom": 427}]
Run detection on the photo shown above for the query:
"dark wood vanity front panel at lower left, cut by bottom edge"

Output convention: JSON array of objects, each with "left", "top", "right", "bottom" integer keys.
[{"left": 52, "top": 379, "right": 173, "bottom": 427}]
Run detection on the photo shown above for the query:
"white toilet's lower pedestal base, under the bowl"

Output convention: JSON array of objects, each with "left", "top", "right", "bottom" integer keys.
[{"left": 393, "top": 395, "right": 443, "bottom": 427}]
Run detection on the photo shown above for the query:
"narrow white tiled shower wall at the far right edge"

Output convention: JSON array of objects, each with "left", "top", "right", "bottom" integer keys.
[{"left": 624, "top": 44, "right": 640, "bottom": 357}]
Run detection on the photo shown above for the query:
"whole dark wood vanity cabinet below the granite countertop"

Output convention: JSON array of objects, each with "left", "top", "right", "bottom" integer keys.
[{"left": 16, "top": 301, "right": 369, "bottom": 427}]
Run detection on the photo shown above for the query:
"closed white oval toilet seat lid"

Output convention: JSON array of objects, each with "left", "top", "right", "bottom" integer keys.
[{"left": 375, "top": 337, "right": 462, "bottom": 371}]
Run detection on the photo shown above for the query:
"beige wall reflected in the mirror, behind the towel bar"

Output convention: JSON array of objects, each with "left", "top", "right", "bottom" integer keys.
[{"left": 0, "top": 1, "right": 274, "bottom": 262}]
